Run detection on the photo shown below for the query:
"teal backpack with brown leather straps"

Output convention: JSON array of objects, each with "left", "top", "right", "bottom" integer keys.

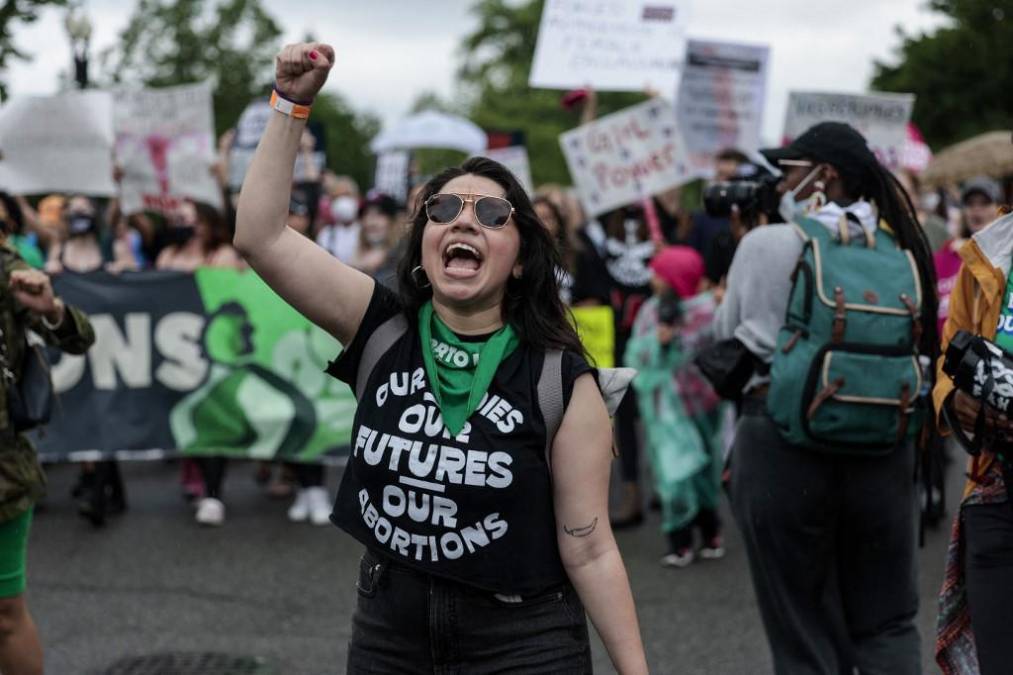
[{"left": 767, "top": 218, "right": 923, "bottom": 455}]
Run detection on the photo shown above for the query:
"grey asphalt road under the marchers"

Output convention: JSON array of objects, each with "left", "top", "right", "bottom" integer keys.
[{"left": 29, "top": 454, "right": 959, "bottom": 675}]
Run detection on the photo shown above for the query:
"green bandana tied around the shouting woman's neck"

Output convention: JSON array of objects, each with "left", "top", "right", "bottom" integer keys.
[{"left": 418, "top": 300, "right": 520, "bottom": 436}]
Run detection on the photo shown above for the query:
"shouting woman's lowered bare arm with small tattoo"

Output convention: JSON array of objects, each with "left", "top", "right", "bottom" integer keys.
[{"left": 552, "top": 374, "right": 647, "bottom": 675}]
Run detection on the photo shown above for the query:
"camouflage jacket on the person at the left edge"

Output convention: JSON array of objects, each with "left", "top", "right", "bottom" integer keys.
[{"left": 0, "top": 240, "right": 95, "bottom": 523}]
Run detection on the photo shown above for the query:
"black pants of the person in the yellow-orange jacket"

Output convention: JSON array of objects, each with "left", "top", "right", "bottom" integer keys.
[{"left": 961, "top": 504, "right": 1013, "bottom": 675}]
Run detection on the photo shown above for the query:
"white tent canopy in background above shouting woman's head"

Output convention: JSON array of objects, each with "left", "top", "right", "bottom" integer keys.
[{"left": 370, "top": 110, "right": 488, "bottom": 155}]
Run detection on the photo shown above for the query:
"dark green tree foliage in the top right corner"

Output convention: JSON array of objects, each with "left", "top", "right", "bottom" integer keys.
[{"left": 872, "top": 0, "right": 1013, "bottom": 149}]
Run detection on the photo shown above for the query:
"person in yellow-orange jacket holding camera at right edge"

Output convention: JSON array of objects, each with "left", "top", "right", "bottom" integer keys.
[{"left": 933, "top": 206, "right": 1013, "bottom": 675}]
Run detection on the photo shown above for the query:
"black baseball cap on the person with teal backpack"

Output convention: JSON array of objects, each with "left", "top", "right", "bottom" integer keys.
[{"left": 760, "top": 122, "right": 878, "bottom": 173}]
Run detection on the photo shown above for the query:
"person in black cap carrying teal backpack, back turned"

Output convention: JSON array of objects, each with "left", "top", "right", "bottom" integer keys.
[{"left": 715, "top": 123, "right": 938, "bottom": 675}]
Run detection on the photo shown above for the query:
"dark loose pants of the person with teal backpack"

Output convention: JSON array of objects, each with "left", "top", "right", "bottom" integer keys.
[{"left": 731, "top": 406, "right": 921, "bottom": 675}]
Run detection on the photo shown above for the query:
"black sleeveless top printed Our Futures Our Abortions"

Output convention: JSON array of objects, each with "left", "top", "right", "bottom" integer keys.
[{"left": 327, "top": 284, "right": 591, "bottom": 595}]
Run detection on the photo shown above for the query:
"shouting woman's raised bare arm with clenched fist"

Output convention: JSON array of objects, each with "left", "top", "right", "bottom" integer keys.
[{"left": 235, "top": 43, "right": 374, "bottom": 345}]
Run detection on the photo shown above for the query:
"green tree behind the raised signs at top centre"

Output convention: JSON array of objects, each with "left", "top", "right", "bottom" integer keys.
[{"left": 459, "top": 0, "right": 645, "bottom": 185}]
